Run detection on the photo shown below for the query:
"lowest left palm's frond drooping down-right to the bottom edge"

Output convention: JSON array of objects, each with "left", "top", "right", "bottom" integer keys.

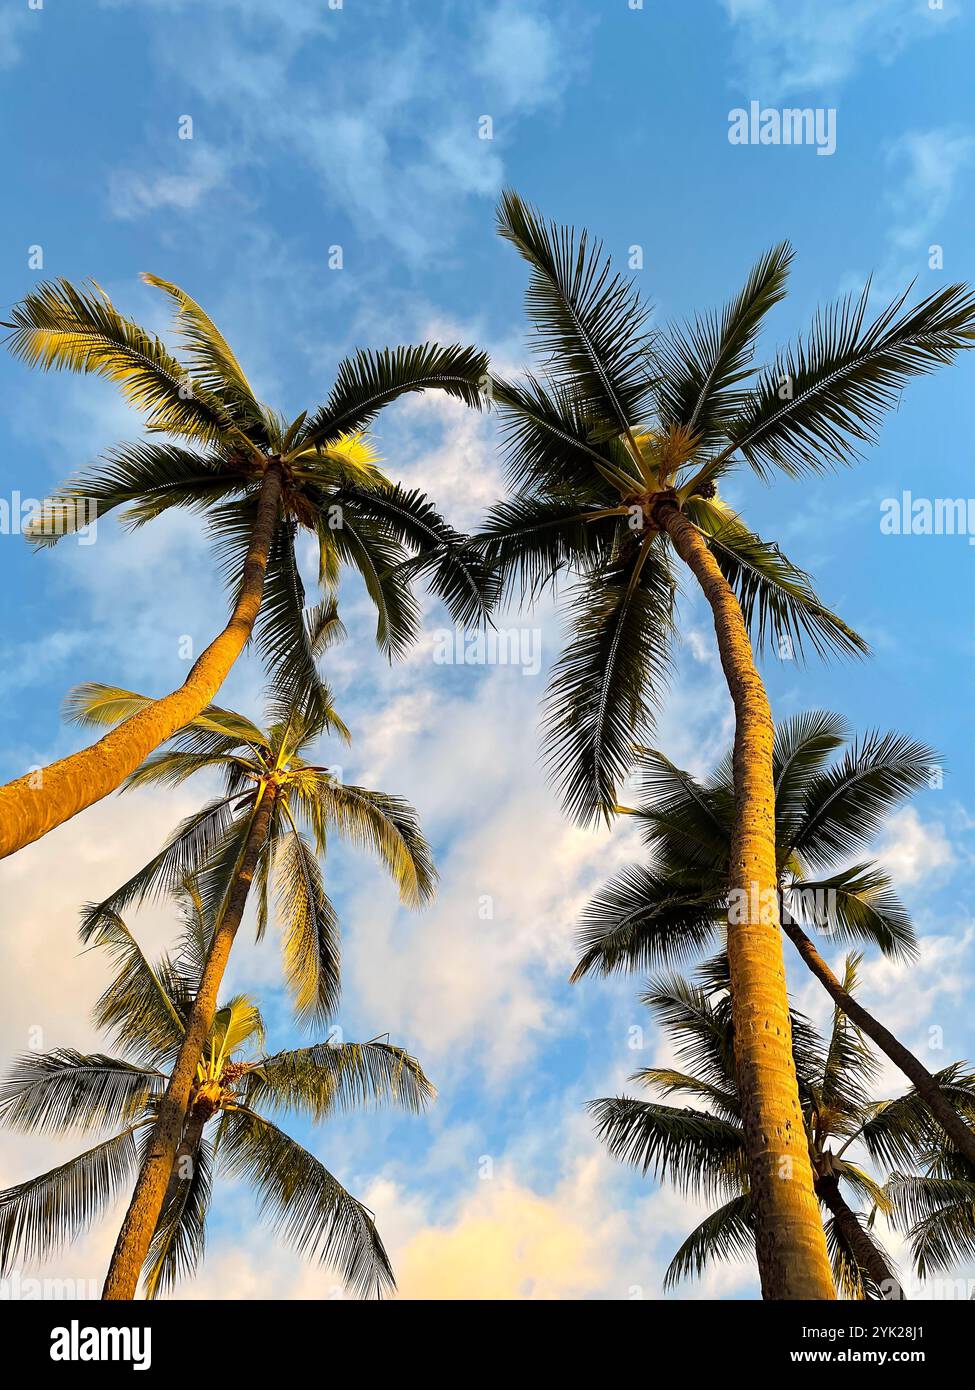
[{"left": 220, "top": 1106, "right": 394, "bottom": 1298}]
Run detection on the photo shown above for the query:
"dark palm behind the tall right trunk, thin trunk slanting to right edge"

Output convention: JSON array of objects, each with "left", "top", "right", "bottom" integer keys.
[{"left": 572, "top": 710, "right": 975, "bottom": 1170}]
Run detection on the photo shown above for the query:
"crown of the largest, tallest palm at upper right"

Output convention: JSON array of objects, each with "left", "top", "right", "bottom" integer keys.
[{"left": 481, "top": 192, "right": 975, "bottom": 821}]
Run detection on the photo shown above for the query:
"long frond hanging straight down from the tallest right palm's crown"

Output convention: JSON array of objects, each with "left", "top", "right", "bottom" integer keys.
[{"left": 542, "top": 538, "right": 673, "bottom": 824}]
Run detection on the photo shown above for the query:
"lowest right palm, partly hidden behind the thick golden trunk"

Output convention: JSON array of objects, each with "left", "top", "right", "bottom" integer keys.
[{"left": 590, "top": 955, "right": 975, "bottom": 1298}]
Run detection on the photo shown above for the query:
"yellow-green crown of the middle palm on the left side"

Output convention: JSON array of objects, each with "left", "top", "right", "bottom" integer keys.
[{"left": 70, "top": 628, "right": 437, "bottom": 1020}]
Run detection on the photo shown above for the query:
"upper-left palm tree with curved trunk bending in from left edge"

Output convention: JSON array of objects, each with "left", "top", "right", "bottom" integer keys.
[{"left": 0, "top": 275, "right": 487, "bottom": 858}]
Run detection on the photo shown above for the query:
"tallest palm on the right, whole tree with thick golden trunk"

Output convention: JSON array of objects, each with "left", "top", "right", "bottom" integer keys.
[{"left": 483, "top": 193, "right": 975, "bottom": 1298}]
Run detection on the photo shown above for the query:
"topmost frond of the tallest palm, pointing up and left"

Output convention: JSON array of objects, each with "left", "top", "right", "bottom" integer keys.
[{"left": 498, "top": 189, "right": 652, "bottom": 436}]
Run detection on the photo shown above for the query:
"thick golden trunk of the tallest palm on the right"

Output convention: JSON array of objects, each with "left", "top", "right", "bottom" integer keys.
[{"left": 654, "top": 493, "right": 836, "bottom": 1300}]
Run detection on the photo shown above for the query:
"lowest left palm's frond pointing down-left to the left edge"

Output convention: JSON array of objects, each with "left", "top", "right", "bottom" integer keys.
[{"left": 0, "top": 1126, "right": 138, "bottom": 1276}]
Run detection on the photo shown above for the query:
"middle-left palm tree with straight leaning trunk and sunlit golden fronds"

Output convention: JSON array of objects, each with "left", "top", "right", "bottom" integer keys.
[{"left": 72, "top": 647, "right": 435, "bottom": 1298}]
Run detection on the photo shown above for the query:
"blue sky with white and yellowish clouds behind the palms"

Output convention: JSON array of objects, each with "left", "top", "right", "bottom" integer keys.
[{"left": 0, "top": 0, "right": 975, "bottom": 1300}]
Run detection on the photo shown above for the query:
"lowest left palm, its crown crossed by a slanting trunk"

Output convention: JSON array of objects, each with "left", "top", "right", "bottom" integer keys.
[{"left": 0, "top": 883, "right": 434, "bottom": 1298}]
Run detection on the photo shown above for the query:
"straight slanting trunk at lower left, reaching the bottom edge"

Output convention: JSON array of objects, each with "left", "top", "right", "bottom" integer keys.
[{"left": 102, "top": 785, "right": 274, "bottom": 1300}]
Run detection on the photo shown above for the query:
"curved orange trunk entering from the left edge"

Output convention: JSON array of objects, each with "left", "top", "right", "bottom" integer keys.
[{"left": 0, "top": 464, "right": 284, "bottom": 859}]
